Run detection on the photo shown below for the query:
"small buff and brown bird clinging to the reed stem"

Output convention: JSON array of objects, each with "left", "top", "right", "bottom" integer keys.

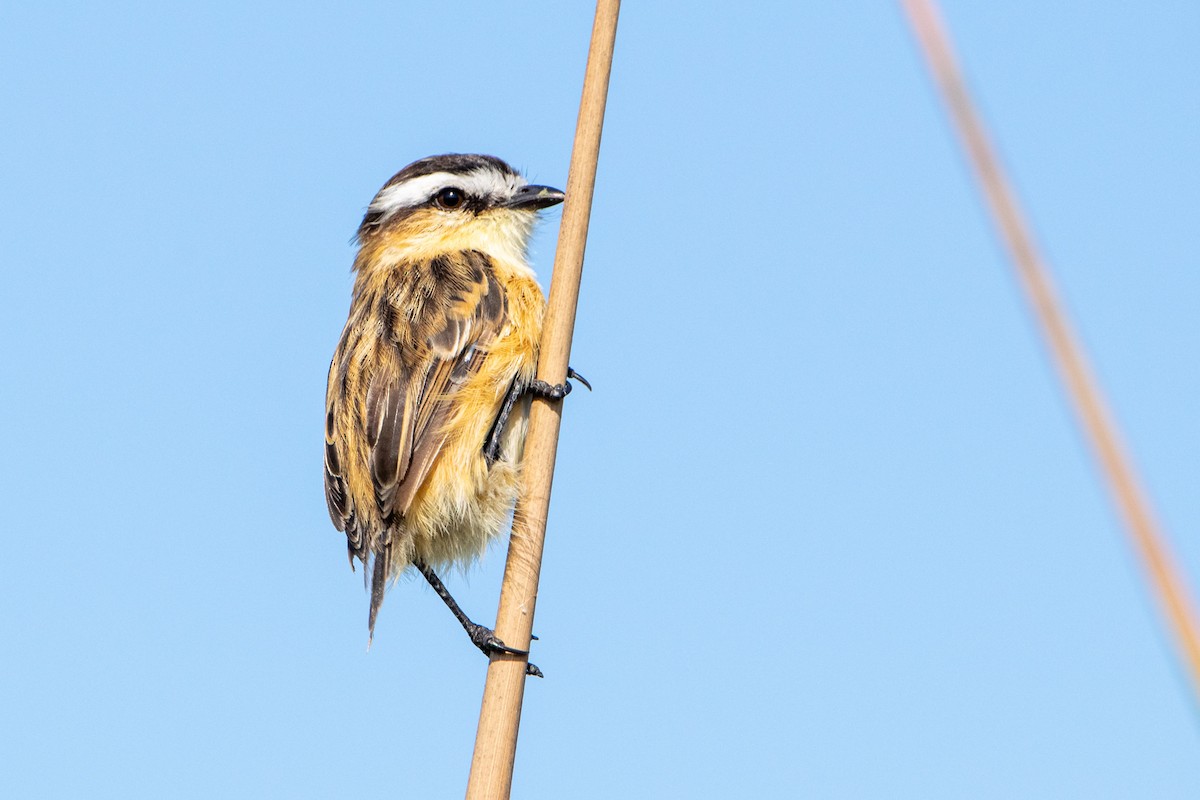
[{"left": 325, "top": 155, "right": 576, "bottom": 674}]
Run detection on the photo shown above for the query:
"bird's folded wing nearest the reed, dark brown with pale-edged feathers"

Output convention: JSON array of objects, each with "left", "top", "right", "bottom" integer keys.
[{"left": 366, "top": 251, "right": 506, "bottom": 519}]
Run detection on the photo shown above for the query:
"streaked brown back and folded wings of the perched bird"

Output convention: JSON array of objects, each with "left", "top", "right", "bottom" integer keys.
[{"left": 324, "top": 251, "right": 508, "bottom": 575}]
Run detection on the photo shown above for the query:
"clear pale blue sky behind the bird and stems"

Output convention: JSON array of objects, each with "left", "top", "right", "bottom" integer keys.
[{"left": 0, "top": 0, "right": 1200, "bottom": 798}]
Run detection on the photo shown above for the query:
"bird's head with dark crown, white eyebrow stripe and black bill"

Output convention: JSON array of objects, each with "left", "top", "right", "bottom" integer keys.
[{"left": 358, "top": 154, "right": 565, "bottom": 264}]
